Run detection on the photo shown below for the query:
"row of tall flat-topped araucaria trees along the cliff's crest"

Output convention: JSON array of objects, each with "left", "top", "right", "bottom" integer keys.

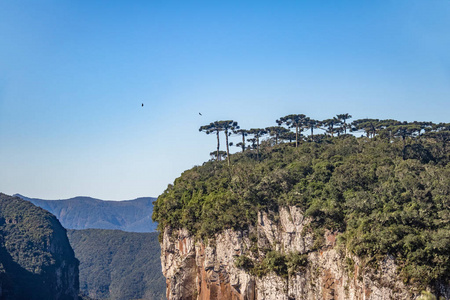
[{"left": 199, "top": 113, "right": 450, "bottom": 165}]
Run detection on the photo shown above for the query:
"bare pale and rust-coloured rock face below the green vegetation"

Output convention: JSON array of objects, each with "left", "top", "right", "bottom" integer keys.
[{"left": 161, "top": 207, "right": 450, "bottom": 300}]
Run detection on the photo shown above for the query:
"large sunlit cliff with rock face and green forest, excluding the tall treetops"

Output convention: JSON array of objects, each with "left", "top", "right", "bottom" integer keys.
[{"left": 153, "top": 136, "right": 450, "bottom": 300}]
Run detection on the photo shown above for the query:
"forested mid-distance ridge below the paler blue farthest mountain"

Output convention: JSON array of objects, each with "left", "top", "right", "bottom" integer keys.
[{"left": 67, "top": 229, "right": 166, "bottom": 300}]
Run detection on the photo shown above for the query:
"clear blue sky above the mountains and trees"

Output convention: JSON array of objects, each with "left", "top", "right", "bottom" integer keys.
[{"left": 0, "top": 0, "right": 450, "bottom": 200}]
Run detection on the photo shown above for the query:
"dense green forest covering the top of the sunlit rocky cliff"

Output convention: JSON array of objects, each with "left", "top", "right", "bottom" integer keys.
[{"left": 153, "top": 129, "right": 450, "bottom": 285}]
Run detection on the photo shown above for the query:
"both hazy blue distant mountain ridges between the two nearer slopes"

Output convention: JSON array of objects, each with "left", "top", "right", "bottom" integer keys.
[{"left": 10, "top": 194, "right": 165, "bottom": 300}]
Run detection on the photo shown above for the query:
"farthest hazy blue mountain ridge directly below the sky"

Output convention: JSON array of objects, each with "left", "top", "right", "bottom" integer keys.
[{"left": 14, "top": 194, "right": 157, "bottom": 232}]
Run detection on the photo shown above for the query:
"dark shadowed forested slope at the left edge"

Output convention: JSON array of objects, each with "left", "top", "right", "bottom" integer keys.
[{"left": 0, "top": 193, "right": 79, "bottom": 300}]
